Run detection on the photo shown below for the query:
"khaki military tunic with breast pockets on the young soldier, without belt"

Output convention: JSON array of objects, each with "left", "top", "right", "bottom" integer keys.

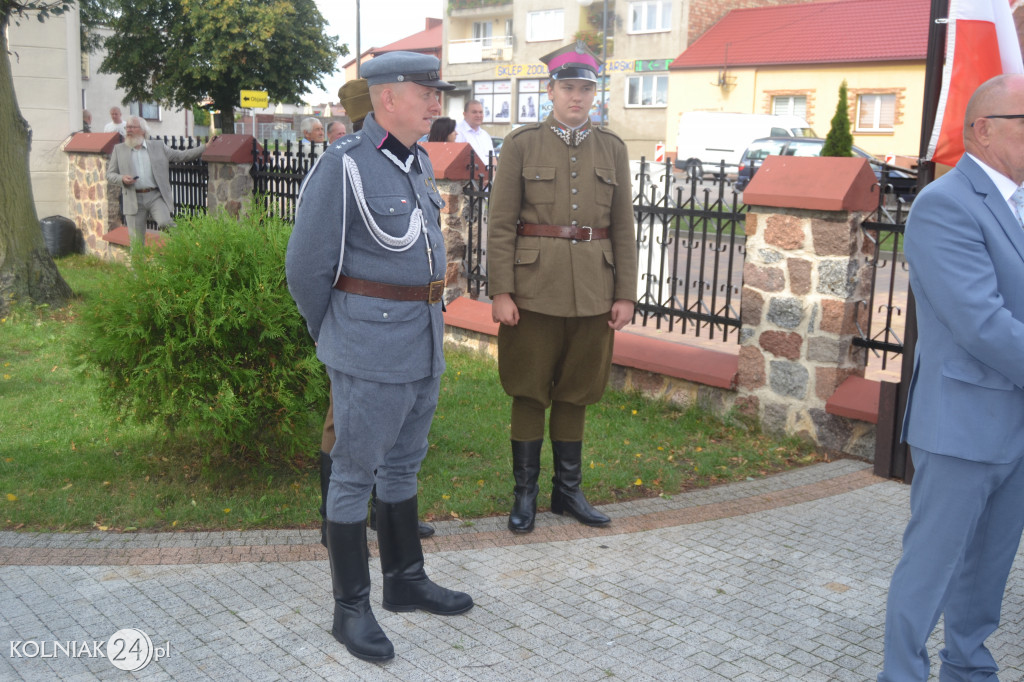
[{"left": 486, "top": 117, "right": 637, "bottom": 317}]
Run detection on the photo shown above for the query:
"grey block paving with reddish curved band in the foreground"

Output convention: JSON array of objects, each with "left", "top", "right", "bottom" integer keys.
[{"left": 0, "top": 460, "right": 1024, "bottom": 682}]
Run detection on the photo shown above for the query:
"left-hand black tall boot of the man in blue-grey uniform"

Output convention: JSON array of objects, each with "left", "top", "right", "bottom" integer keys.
[{"left": 325, "top": 521, "right": 394, "bottom": 663}]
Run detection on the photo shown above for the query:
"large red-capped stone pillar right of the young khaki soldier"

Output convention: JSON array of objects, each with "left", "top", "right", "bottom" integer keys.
[{"left": 736, "top": 157, "right": 878, "bottom": 452}]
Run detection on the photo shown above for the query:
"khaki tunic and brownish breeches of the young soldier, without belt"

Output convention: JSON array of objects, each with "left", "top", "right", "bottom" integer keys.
[{"left": 487, "top": 117, "right": 637, "bottom": 441}]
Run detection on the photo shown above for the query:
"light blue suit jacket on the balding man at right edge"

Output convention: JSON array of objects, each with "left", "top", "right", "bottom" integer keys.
[{"left": 903, "top": 155, "right": 1024, "bottom": 464}]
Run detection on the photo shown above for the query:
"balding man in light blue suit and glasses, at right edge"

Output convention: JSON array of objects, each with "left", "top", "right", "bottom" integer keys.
[{"left": 878, "top": 75, "right": 1024, "bottom": 682}]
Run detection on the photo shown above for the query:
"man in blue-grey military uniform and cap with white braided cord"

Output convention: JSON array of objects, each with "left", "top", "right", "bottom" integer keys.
[{"left": 286, "top": 52, "right": 473, "bottom": 662}]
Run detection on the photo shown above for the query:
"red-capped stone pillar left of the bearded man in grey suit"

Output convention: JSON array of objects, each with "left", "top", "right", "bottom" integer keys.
[{"left": 65, "top": 133, "right": 121, "bottom": 258}]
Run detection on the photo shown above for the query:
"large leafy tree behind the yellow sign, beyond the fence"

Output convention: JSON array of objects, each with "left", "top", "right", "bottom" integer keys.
[{"left": 99, "top": 0, "right": 348, "bottom": 130}]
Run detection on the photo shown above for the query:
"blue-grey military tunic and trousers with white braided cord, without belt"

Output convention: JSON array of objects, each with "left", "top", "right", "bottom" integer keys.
[{"left": 286, "top": 114, "right": 445, "bottom": 523}]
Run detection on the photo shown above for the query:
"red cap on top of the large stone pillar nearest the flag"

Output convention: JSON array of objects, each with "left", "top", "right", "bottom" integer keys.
[{"left": 743, "top": 157, "right": 879, "bottom": 211}]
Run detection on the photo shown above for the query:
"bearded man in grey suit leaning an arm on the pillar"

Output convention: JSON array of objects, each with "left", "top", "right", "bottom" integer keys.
[{"left": 106, "top": 116, "right": 206, "bottom": 244}]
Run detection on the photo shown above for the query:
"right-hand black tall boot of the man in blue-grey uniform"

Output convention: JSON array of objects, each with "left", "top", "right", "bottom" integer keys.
[{"left": 377, "top": 496, "right": 473, "bottom": 615}]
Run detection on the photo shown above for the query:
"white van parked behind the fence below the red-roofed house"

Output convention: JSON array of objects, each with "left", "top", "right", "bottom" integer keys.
[{"left": 676, "top": 112, "right": 817, "bottom": 178}]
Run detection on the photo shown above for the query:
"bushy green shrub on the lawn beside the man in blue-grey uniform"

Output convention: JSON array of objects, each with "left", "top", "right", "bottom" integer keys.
[{"left": 81, "top": 208, "right": 328, "bottom": 462}]
